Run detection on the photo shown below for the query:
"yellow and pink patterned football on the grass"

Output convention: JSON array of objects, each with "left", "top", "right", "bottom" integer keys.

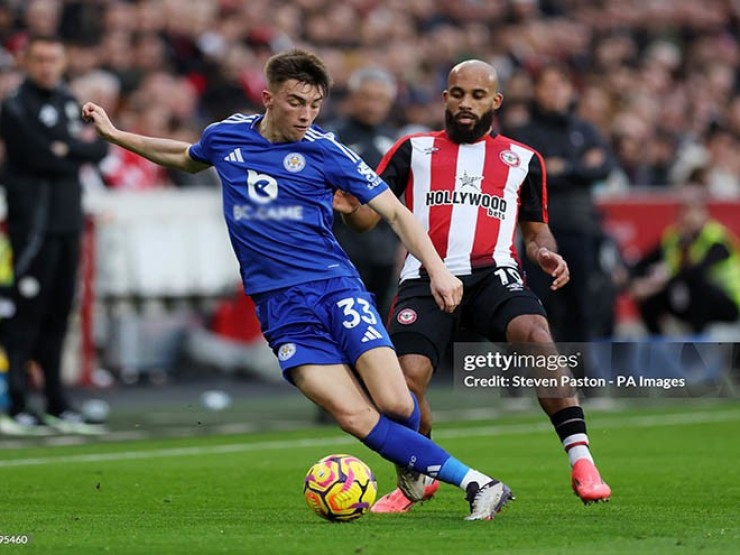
[{"left": 303, "top": 454, "right": 378, "bottom": 522}]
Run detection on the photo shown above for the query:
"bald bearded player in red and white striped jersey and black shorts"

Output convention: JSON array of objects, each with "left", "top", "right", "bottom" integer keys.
[{"left": 335, "top": 60, "right": 611, "bottom": 513}]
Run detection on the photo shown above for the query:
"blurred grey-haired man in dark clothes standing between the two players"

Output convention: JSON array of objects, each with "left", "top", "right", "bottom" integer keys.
[{"left": 325, "top": 67, "right": 399, "bottom": 315}]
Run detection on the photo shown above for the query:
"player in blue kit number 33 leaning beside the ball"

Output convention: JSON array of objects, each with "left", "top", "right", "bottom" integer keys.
[{"left": 82, "top": 50, "right": 513, "bottom": 520}]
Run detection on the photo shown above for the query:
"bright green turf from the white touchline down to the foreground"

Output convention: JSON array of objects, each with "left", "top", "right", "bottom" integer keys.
[{"left": 0, "top": 403, "right": 740, "bottom": 555}]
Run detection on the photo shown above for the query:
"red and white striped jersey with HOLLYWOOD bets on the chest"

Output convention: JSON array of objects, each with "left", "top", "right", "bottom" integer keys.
[{"left": 377, "top": 131, "right": 547, "bottom": 281}]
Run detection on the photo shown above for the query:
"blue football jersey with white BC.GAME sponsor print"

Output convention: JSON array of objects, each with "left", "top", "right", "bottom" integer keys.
[{"left": 190, "top": 114, "right": 388, "bottom": 295}]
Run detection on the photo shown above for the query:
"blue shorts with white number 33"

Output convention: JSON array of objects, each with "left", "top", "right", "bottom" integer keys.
[{"left": 253, "top": 277, "right": 393, "bottom": 381}]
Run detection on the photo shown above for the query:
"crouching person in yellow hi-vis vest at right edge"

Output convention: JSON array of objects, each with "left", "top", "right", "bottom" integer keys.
[{"left": 629, "top": 185, "right": 740, "bottom": 335}]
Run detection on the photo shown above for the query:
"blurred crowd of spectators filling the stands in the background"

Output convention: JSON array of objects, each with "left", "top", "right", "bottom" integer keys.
[{"left": 0, "top": 0, "right": 740, "bottom": 198}]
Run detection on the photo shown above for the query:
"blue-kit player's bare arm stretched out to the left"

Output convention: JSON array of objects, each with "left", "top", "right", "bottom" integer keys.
[{"left": 82, "top": 102, "right": 209, "bottom": 173}]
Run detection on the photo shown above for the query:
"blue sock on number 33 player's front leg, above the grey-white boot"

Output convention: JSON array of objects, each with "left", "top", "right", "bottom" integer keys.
[{"left": 362, "top": 414, "right": 469, "bottom": 486}]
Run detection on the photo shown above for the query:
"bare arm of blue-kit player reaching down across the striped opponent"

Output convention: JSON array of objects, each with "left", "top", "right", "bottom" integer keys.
[{"left": 368, "top": 189, "right": 463, "bottom": 312}]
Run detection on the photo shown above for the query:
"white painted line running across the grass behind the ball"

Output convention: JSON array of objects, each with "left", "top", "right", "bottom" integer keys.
[{"left": 0, "top": 410, "right": 740, "bottom": 468}]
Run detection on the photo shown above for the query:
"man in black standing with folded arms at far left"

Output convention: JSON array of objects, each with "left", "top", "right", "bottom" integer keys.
[{"left": 0, "top": 36, "right": 107, "bottom": 434}]
